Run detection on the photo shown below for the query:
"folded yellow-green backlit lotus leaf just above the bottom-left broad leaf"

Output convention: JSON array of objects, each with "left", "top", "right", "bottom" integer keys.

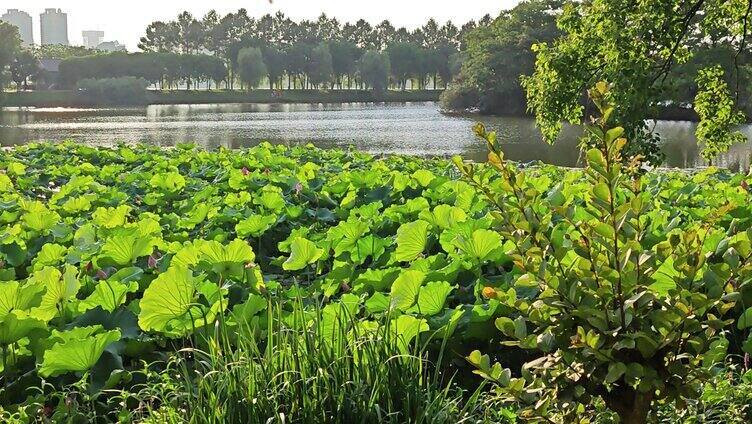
[{"left": 28, "top": 265, "right": 81, "bottom": 322}]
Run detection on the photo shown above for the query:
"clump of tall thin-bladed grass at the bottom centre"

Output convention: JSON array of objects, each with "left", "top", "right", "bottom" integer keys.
[{"left": 128, "top": 303, "right": 494, "bottom": 424}]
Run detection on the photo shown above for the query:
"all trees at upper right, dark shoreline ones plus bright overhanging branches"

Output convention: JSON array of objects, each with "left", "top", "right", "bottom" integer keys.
[{"left": 443, "top": 0, "right": 752, "bottom": 163}]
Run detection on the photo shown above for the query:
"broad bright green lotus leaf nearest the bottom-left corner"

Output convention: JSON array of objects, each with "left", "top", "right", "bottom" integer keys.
[{"left": 39, "top": 325, "right": 120, "bottom": 377}]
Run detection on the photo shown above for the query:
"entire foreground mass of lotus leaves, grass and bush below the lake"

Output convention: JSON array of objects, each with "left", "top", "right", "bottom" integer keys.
[{"left": 0, "top": 84, "right": 752, "bottom": 423}]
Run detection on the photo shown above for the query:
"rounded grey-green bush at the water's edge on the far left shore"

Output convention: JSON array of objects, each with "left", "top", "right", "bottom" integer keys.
[{"left": 76, "top": 77, "right": 149, "bottom": 105}]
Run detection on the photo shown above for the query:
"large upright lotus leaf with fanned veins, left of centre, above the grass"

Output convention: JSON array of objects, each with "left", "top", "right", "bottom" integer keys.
[{"left": 138, "top": 266, "right": 214, "bottom": 337}]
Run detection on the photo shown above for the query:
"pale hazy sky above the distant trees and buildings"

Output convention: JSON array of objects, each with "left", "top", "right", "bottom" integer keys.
[{"left": 10, "top": 0, "right": 518, "bottom": 50}]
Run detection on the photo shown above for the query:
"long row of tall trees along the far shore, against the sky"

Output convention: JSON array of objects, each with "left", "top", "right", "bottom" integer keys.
[{"left": 134, "top": 9, "right": 491, "bottom": 90}]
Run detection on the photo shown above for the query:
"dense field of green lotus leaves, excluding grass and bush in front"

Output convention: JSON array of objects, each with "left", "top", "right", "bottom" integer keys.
[{"left": 0, "top": 143, "right": 752, "bottom": 422}]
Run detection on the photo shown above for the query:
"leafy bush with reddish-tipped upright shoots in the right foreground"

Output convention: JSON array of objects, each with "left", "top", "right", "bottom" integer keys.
[{"left": 456, "top": 83, "right": 752, "bottom": 424}]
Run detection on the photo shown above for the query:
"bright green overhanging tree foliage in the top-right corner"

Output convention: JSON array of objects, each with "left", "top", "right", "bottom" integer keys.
[{"left": 524, "top": 0, "right": 752, "bottom": 163}]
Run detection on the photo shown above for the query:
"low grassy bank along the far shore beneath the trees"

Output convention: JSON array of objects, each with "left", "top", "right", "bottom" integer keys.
[{"left": 2, "top": 90, "right": 441, "bottom": 107}]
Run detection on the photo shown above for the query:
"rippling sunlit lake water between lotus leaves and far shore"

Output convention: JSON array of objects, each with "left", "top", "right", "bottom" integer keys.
[{"left": 0, "top": 103, "right": 752, "bottom": 170}]
